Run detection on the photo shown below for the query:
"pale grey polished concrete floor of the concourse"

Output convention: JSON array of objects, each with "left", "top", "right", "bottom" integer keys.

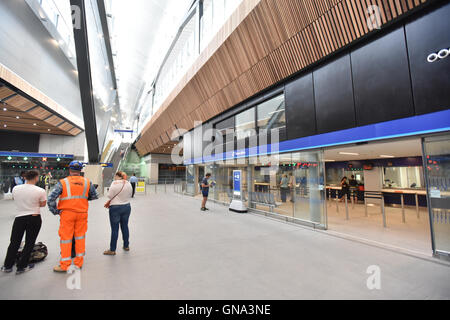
[{"left": 0, "top": 192, "right": 450, "bottom": 300}]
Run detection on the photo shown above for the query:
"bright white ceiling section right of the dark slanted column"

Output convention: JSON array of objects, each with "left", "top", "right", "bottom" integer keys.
[{"left": 107, "top": 0, "right": 193, "bottom": 124}]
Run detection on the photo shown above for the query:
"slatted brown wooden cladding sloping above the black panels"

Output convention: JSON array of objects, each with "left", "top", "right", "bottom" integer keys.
[{"left": 136, "top": 0, "right": 432, "bottom": 154}]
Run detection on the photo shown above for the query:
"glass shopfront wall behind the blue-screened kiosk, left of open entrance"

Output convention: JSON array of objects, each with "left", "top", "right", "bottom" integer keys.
[{"left": 192, "top": 151, "right": 326, "bottom": 227}]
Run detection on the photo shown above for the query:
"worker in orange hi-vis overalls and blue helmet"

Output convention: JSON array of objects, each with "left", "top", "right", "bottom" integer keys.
[{"left": 48, "top": 161, "right": 98, "bottom": 272}]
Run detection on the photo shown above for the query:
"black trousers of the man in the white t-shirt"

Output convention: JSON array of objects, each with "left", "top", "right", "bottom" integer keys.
[{"left": 4, "top": 215, "right": 42, "bottom": 269}]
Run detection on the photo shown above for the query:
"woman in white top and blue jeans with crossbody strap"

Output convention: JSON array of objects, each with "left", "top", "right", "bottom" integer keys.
[{"left": 103, "top": 171, "right": 133, "bottom": 256}]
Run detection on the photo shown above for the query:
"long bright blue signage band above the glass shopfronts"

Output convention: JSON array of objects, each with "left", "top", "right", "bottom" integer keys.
[{"left": 184, "top": 109, "right": 450, "bottom": 165}]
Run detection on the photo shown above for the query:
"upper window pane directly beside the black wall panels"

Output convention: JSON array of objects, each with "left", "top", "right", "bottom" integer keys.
[{"left": 258, "top": 94, "right": 286, "bottom": 130}]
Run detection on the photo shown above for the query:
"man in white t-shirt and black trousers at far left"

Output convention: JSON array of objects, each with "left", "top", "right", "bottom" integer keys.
[{"left": 1, "top": 171, "right": 47, "bottom": 274}]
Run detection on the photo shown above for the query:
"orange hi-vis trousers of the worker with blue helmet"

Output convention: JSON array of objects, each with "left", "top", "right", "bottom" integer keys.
[{"left": 59, "top": 211, "right": 88, "bottom": 270}]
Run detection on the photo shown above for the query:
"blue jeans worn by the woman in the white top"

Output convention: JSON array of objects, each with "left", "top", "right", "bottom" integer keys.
[{"left": 109, "top": 204, "right": 131, "bottom": 252}]
